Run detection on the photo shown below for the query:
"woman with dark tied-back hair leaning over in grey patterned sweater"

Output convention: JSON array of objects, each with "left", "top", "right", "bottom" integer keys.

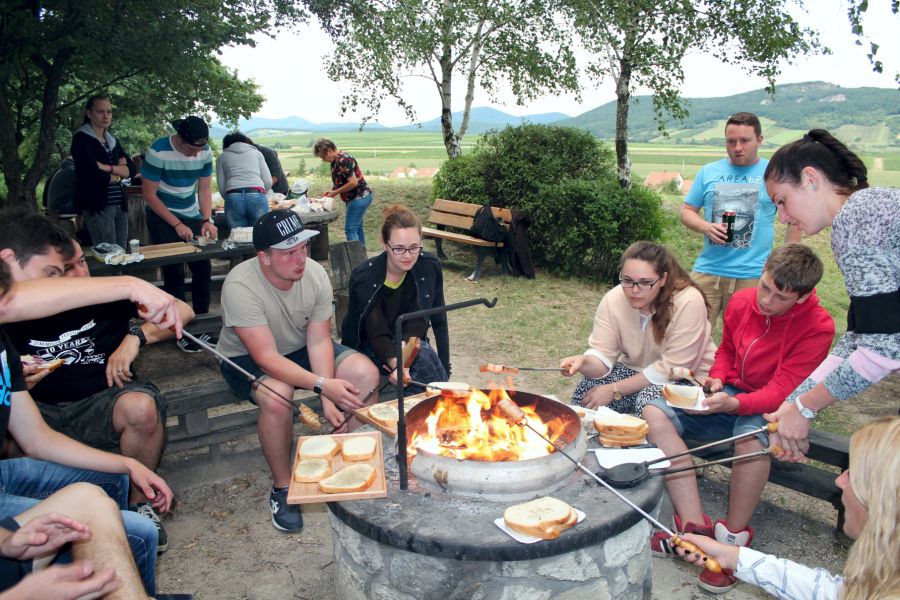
[{"left": 765, "top": 129, "right": 900, "bottom": 461}]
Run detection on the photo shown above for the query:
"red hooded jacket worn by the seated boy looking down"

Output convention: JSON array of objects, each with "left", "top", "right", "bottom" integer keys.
[{"left": 709, "top": 288, "right": 834, "bottom": 415}]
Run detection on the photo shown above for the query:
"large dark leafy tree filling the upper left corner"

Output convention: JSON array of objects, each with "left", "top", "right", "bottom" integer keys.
[{"left": 0, "top": 0, "right": 301, "bottom": 206}]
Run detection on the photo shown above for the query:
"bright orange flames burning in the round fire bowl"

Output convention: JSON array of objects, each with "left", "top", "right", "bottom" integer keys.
[{"left": 409, "top": 389, "right": 564, "bottom": 462}]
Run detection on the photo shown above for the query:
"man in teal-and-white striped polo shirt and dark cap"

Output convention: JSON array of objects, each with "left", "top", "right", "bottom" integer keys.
[{"left": 141, "top": 116, "right": 217, "bottom": 330}]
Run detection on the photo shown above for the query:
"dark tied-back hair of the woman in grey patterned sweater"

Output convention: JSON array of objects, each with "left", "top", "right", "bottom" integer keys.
[{"left": 765, "top": 129, "right": 869, "bottom": 195}]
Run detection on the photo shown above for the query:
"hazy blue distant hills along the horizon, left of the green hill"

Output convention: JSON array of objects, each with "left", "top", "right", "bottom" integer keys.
[{"left": 211, "top": 107, "right": 569, "bottom": 139}]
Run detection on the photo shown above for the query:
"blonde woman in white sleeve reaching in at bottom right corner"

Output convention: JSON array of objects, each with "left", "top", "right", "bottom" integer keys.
[{"left": 679, "top": 417, "right": 900, "bottom": 600}]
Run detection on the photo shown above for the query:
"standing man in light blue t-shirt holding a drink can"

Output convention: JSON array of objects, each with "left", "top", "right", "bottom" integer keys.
[{"left": 681, "top": 112, "right": 800, "bottom": 324}]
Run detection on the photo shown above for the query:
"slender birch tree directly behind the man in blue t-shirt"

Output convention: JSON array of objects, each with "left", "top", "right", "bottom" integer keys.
[{"left": 561, "top": 0, "right": 819, "bottom": 187}]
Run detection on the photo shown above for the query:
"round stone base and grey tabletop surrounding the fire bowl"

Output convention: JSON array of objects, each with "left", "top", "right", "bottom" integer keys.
[{"left": 328, "top": 424, "right": 663, "bottom": 600}]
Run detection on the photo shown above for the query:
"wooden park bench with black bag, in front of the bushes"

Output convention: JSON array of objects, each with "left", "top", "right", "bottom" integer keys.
[{"left": 422, "top": 198, "right": 512, "bottom": 281}]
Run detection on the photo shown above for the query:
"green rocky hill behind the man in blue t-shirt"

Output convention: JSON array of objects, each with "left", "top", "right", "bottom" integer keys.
[{"left": 554, "top": 81, "right": 900, "bottom": 148}]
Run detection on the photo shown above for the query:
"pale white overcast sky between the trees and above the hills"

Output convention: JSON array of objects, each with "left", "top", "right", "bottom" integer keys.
[{"left": 222, "top": 0, "right": 900, "bottom": 126}]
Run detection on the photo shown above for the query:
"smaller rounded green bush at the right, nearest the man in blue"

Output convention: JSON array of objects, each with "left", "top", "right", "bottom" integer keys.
[{"left": 519, "top": 178, "right": 663, "bottom": 281}]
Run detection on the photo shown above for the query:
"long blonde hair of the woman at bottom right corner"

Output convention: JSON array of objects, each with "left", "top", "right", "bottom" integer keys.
[{"left": 841, "top": 417, "right": 900, "bottom": 600}]
